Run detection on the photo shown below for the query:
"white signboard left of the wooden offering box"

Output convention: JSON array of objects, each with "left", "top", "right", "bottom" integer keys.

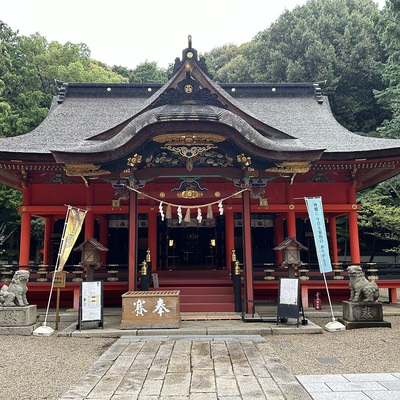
[{"left": 81, "top": 281, "right": 103, "bottom": 321}]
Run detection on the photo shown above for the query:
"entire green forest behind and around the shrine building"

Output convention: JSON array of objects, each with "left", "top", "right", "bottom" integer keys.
[{"left": 0, "top": 0, "right": 400, "bottom": 261}]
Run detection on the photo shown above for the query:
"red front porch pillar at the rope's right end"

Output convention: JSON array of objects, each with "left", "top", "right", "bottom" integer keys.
[{"left": 242, "top": 190, "right": 254, "bottom": 306}]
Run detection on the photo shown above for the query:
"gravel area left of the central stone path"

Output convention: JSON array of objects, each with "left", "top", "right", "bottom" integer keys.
[{"left": 0, "top": 335, "right": 115, "bottom": 400}]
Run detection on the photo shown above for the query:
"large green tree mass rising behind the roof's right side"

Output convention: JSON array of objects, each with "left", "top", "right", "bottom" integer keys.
[{"left": 205, "top": 0, "right": 384, "bottom": 133}]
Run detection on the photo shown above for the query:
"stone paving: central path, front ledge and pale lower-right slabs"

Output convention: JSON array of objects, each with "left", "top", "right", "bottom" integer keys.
[{"left": 53, "top": 306, "right": 400, "bottom": 400}]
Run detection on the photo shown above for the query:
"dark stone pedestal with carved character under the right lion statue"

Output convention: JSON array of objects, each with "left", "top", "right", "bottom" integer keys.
[{"left": 338, "top": 301, "right": 392, "bottom": 329}]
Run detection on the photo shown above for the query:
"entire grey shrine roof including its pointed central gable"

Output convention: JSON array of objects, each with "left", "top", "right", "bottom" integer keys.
[{"left": 0, "top": 40, "right": 400, "bottom": 166}]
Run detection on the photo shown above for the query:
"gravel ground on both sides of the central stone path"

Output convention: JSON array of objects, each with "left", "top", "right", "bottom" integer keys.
[{"left": 0, "top": 316, "right": 400, "bottom": 400}]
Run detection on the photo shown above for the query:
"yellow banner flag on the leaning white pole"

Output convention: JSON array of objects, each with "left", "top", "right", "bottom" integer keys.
[{"left": 57, "top": 208, "right": 86, "bottom": 271}]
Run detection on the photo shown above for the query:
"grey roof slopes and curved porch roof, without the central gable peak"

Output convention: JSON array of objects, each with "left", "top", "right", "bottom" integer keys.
[{"left": 0, "top": 77, "right": 400, "bottom": 159}]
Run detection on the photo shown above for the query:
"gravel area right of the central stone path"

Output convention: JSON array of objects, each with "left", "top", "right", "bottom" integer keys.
[{"left": 266, "top": 316, "right": 400, "bottom": 375}]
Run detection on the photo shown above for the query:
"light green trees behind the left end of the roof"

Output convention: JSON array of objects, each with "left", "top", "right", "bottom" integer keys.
[{"left": 0, "top": 21, "right": 126, "bottom": 137}]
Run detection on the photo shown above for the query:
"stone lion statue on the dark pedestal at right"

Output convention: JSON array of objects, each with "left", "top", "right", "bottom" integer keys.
[{"left": 347, "top": 265, "right": 379, "bottom": 303}]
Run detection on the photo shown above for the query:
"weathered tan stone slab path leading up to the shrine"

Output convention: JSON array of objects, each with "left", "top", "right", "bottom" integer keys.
[{"left": 61, "top": 336, "right": 310, "bottom": 400}]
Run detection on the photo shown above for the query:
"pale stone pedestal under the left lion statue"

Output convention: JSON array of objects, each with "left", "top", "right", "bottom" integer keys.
[{"left": 0, "top": 305, "right": 37, "bottom": 336}]
